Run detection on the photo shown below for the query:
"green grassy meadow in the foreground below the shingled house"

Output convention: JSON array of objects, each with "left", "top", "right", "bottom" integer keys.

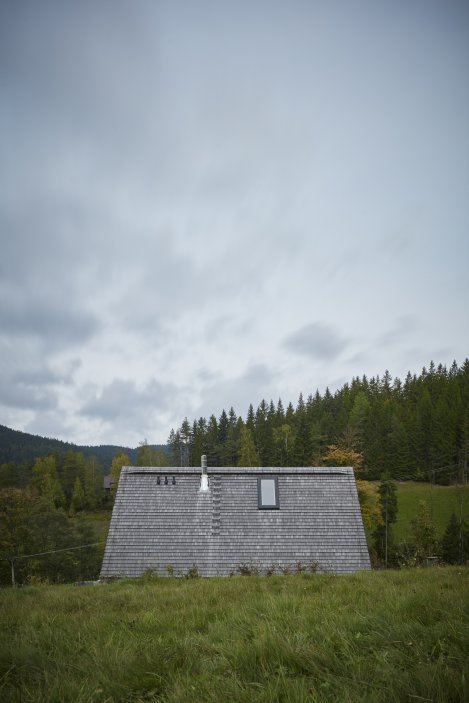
[{"left": 0, "top": 567, "right": 469, "bottom": 703}]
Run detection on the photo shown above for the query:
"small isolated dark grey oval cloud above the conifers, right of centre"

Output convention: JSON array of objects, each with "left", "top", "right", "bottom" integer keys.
[{"left": 284, "top": 322, "right": 349, "bottom": 361}]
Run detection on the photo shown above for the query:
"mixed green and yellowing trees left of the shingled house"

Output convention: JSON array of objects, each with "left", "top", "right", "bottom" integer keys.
[{"left": 0, "top": 440, "right": 166, "bottom": 584}]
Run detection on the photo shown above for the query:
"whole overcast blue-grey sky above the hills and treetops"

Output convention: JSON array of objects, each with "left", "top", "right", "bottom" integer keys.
[{"left": 0, "top": 0, "right": 469, "bottom": 446}]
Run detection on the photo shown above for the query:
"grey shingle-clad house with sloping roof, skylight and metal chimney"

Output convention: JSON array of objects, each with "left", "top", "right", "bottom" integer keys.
[{"left": 101, "top": 457, "right": 370, "bottom": 579}]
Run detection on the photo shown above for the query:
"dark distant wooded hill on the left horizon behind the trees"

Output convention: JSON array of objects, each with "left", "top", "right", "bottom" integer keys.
[{"left": 0, "top": 425, "right": 166, "bottom": 471}]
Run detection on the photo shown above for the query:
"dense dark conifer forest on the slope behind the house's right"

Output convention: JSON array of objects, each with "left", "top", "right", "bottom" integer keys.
[{"left": 168, "top": 359, "right": 469, "bottom": 483}]
